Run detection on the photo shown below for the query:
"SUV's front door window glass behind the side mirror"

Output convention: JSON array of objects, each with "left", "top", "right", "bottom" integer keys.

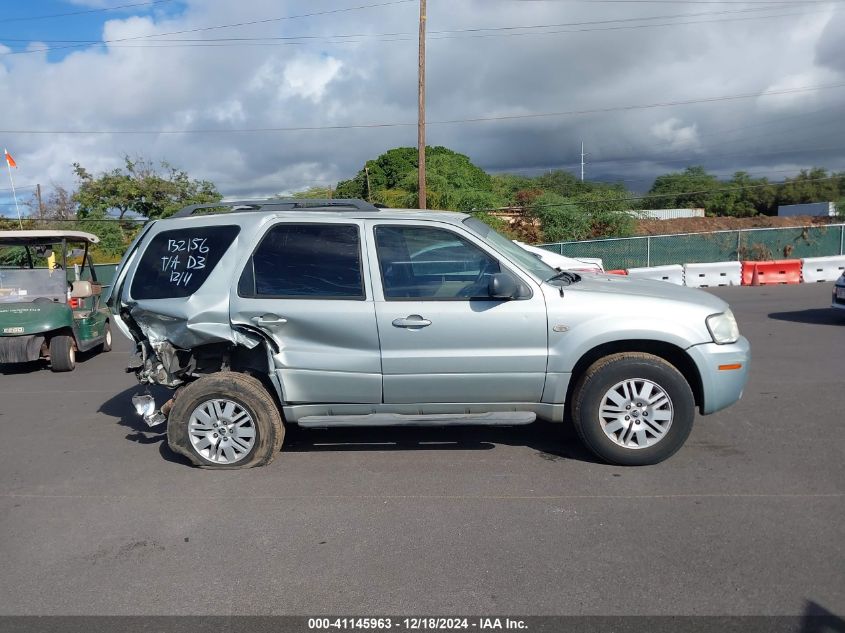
[{"left": 375, "top": 225, "right": 500, "bottom": 300}]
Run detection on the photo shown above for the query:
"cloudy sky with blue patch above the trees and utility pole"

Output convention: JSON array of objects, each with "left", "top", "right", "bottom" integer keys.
[{"left": 0, "top": 0, "right": 845, "bottom": 213}]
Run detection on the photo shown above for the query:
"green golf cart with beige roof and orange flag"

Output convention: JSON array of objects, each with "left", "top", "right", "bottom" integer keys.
[{"left": 0, "top": 231, "right": 112, "bottom": 371}]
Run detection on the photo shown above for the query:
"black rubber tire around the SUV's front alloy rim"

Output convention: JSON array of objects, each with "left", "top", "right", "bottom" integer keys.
[{"left": 572, "top": 352, "right": 695, "bottom": 466}]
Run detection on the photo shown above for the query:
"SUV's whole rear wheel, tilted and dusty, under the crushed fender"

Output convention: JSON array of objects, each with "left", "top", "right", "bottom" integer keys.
[{"left": 167, "top": 372, "right": 285, "bottom": 470}]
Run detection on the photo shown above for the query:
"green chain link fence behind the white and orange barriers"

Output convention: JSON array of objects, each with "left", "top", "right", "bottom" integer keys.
[{"left": 540, "top": 224, "right": 845, "bottom": 270}]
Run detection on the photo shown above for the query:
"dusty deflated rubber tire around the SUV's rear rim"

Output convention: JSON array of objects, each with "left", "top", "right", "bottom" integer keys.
[{"left": 167, "top": 372, "right": 285, "bottom": 470}]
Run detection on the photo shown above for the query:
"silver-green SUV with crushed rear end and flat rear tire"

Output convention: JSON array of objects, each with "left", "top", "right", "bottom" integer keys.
[{"left": 109, "top": 199, "right": 749, "bottom": 468}]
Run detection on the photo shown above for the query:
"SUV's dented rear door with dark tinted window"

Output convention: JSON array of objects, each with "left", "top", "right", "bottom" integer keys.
[{"left": 230, "top": 218, "right": 382, "bottom": 404}]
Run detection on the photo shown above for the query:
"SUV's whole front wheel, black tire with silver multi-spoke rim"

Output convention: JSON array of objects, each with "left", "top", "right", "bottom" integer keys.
[{"left": 572, "top": 352, "right": 695, "bottom": 466}]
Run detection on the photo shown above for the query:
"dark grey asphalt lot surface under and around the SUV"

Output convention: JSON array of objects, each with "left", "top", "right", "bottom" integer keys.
[{"left": 0, "top": 284, "right": 845, "bottom": 615}]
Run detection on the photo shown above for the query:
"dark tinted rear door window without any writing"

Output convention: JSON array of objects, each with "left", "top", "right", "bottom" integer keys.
[{"left": 238, "top": 224, "right": 364, "bottom": 299}]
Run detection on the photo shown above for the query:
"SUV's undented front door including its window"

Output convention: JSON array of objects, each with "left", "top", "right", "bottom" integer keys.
[{"left": 368, "top": 221, "right": 547, "bottom": 403}]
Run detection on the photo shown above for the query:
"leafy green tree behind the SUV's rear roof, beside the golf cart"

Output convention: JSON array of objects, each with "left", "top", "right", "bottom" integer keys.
[{"left": 73, "top": 156, "right": 222, "bottom": 219}]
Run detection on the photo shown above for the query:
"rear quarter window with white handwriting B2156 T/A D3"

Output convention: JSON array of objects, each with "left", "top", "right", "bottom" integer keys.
[{"left": 131, "top": 226, "right": 241, "bottom": 299}]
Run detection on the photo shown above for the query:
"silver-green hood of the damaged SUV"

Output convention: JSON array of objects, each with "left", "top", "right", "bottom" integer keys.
[{"left": 563, "top": 275, "right": 729, "bottom": 314}]
